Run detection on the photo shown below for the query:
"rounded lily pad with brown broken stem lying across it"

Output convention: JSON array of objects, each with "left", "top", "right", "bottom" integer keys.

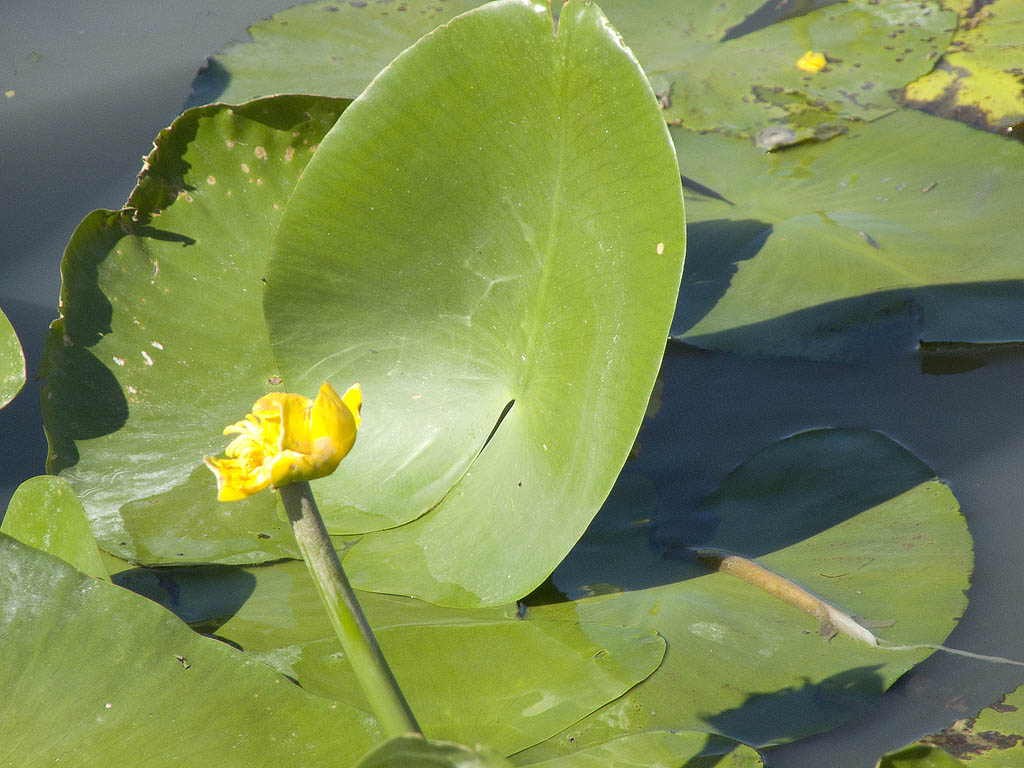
[{"left": 516, "top": 430, "right": 972, "bottom": 764}]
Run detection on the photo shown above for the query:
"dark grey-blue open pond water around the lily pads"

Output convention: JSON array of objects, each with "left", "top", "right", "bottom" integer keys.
[{"left": 0, "top": 0, "right": 1024, "bottom": 768}]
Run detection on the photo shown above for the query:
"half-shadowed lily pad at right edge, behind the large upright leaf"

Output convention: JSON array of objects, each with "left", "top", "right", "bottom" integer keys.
[{"left": 672, "top": 111, "right": 1024, "bottom": 359}]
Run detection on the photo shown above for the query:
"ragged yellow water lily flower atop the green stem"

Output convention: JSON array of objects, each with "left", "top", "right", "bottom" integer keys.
[{"left": 204, "top": 382, "right": 362, "bottom": 502}]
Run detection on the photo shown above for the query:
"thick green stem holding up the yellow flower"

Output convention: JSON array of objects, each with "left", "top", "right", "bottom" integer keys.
[{"left": 280, "top": 482, "right": 421, "bottom": 737}]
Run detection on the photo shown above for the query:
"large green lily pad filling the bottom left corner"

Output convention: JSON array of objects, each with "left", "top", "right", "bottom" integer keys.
[{"left": 0, "top": 535, "right": 381, "bottom": 768}]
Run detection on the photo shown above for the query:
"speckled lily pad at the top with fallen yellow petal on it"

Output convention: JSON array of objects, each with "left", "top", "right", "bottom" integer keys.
[{"left": 602, "top": 0, "right": 956, "bottom": 148}]
